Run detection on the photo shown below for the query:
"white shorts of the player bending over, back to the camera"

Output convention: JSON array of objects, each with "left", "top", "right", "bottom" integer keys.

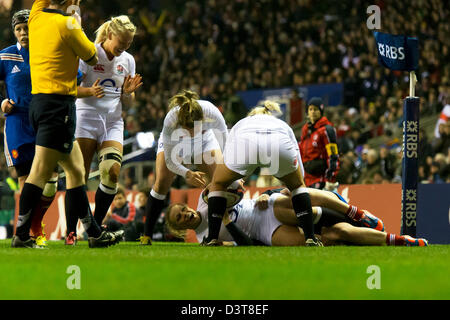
[{"left": 223, "top": 130, "right": 303, "bottom": 178}]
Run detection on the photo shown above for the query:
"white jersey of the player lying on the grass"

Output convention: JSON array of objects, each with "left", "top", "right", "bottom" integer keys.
[{"left": 195, "top": 194, "right": 257, "bottom": 243}]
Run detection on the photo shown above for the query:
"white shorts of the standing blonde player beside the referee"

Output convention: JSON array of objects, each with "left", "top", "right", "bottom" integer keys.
[{"left": 75, "top": 110, "right": 124, "bottom": 144}]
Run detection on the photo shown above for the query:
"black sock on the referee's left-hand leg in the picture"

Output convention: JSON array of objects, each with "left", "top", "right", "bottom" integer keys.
[{"left": 16, "top": 183, "right": 43, "bottom": 241}]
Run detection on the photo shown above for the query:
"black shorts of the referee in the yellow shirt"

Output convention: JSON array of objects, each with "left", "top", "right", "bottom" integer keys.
[{"left": 29, "top": 94, "right": 77, "bottom": 153}]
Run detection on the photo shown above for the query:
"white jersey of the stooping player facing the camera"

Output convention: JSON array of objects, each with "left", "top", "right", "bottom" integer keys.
[{"left": 162, "top": 100, "right": 228, "bottom": 177}]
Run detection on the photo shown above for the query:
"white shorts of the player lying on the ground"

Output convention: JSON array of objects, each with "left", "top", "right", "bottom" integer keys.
[{"left": 252, "top": 193, "right": 282, "bottom": 246}]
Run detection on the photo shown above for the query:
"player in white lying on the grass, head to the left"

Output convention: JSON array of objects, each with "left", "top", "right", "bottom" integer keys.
[{"left": 166, "top": 189, "right": 428, "bottom": 246}]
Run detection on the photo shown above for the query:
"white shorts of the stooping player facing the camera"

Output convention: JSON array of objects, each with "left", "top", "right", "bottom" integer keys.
[{"left": 156, "top": 130, "right": 220, "bottom": 164}]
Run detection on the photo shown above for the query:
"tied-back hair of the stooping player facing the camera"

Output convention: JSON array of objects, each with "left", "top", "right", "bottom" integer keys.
[{"left": 169, "top": 90, "right": 203, "bottom": 128}]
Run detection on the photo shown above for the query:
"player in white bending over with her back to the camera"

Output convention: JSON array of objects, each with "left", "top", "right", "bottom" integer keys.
[{"left": 206, "top": 100, "right": 322, "bottom": 246}]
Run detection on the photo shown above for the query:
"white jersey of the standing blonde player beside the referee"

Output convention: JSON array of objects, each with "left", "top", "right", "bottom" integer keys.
[{"left": 76, "top": 44, "right": 136, "bottom": 115}]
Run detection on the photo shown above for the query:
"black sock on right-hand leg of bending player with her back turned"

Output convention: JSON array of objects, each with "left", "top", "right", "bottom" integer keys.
[{"left": 292, "top": 187, "right": 315, "bottom": 240}]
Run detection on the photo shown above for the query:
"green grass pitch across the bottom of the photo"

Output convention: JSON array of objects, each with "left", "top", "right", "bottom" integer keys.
[{"left": 0, "top": 240, "right": 450, "bottom": 300}]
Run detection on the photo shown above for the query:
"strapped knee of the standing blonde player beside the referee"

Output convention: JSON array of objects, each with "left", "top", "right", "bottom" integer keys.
[{"left": 98, "top": 147, "right": 122, "bottom": 193}]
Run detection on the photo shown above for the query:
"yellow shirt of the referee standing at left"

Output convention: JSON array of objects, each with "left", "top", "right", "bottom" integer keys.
[{"left": 28, "top": 0, "right": 97, "bottom": 96}]
